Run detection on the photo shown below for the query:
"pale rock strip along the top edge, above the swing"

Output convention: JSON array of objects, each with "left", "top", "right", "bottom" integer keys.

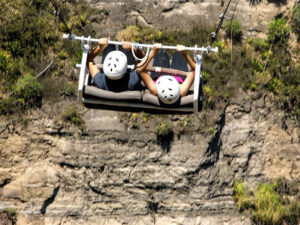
[{"left": 87, "top": 0, "right": 295, "bottom": 38}]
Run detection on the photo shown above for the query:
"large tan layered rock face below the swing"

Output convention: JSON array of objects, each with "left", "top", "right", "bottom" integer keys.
[{"left": 0, "top": 94, "right": 300, "bottom": 225}]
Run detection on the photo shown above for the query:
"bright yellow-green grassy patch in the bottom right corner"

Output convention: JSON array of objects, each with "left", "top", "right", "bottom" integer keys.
[{"left": 233, "top": 178, "right": 300, "bottom": 225}]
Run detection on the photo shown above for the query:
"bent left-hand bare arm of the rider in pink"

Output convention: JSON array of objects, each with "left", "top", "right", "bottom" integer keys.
[{"left": 136, "top": 44, "right": 161, "bottom": 95}]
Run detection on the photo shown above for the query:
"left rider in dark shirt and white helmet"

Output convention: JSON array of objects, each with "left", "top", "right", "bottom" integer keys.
[{"left": 87, "top": 38, "right": 143, "bottom": 92}]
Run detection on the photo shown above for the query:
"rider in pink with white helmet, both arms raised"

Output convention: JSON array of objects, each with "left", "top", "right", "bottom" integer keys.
[{"left": 137, "top": 43, "right": 196, "bottom": 105}]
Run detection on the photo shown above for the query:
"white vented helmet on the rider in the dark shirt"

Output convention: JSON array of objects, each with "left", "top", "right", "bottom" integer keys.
[{"left": 103, "top": 51, "right": 127, "bottom": 80}]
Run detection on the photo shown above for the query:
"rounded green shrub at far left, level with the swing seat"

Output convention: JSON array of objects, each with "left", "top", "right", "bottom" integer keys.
[{"left": 12, "top": 74, "right": 42, "bottom": 108}]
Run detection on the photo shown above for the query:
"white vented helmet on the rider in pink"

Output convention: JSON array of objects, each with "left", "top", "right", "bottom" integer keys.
[{"left": 156, "top": 75, "right": 180, "bottom": 104}]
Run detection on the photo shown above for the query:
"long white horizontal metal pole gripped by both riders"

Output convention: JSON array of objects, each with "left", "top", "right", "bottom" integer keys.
[{"left": 63, "top": 34, "right": 218, "bottom": 52}]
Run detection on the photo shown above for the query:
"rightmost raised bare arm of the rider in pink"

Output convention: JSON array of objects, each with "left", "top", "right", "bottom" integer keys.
[{"left": 177, "top": 45, "right": 196, "bottom": 97}]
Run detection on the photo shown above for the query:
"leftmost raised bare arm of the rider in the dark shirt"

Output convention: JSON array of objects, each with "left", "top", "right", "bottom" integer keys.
[{"left": 87, "top": 38, "right": 108, "bottom": 78}]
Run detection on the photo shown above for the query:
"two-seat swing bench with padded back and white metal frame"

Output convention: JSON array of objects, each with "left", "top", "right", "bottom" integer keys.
[{"left": 63, "top": 34, "right": 218, "bottom": 115}]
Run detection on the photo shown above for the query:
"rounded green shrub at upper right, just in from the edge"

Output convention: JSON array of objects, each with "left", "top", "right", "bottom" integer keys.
[{"left": 268, "top": 18, "right": 290, "bottom": 45}]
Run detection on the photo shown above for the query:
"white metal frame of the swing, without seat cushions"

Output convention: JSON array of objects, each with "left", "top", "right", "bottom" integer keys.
[{"left": 68, "top": 34, "right": 218, "bottom": 116}]
